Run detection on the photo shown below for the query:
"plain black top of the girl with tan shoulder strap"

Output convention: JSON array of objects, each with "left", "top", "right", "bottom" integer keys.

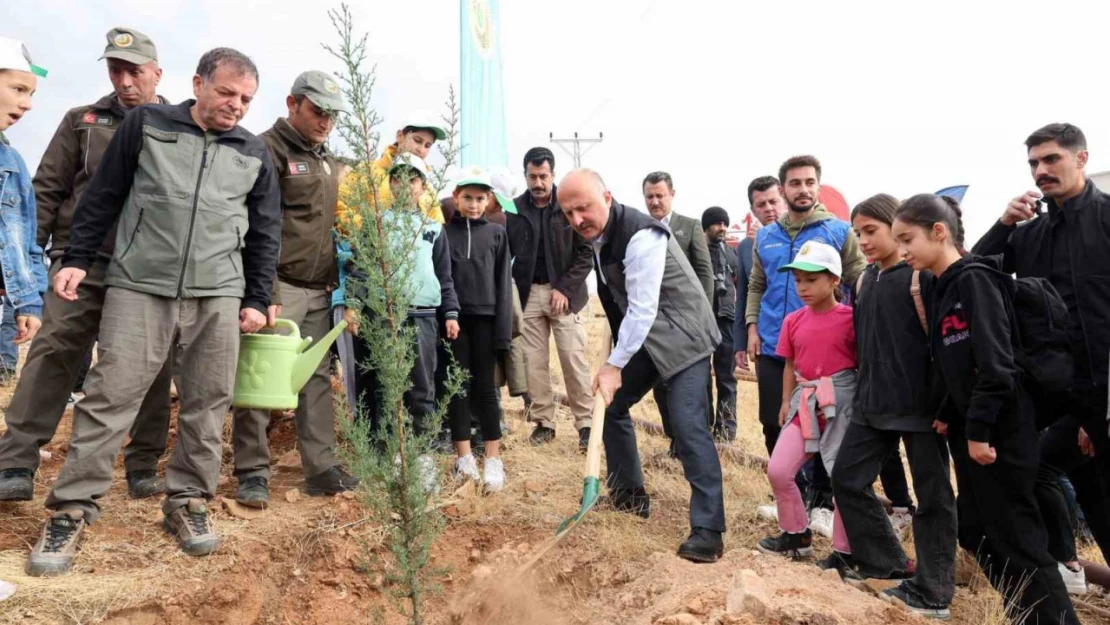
[{"left": 851, "top": 262, "right": 937, "bottom": 432}]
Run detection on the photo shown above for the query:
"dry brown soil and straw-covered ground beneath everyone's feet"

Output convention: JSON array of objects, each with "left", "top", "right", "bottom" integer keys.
[{"left": 0, "top": 306, "right": 1110, "bottom": 625}]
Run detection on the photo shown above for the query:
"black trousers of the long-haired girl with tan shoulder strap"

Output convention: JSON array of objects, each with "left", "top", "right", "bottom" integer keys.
[{"left": 833, "top": 422, "right": 956, "bottom": 605}]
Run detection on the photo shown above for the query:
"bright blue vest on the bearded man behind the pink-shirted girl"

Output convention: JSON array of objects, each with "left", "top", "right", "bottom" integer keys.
[{"left": 745, "top": 210, "right": 864, "bottom": 357}]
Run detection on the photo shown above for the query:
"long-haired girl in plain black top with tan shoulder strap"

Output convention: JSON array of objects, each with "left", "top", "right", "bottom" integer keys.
[{"left": 833, "top": 194, "right": 956, "bottom": 619}]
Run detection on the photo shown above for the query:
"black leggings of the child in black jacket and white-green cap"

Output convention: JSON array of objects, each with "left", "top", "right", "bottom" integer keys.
[{"left": 448, "top": 315, "right": 501, "bottom": 443}]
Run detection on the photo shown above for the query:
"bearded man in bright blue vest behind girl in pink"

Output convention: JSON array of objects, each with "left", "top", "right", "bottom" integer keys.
[{"left": 744, "top": 155, "right": 867, "bottom": 534}]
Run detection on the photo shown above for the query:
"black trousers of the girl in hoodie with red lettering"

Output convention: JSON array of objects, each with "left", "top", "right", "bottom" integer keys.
[{"left": 948, "top": 406, "right": 1079, "bottom": 625}]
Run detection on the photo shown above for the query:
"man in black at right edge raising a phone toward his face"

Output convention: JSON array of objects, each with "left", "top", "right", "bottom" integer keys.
[{"left": 973, "top": 123, "right": 1110, "bottom": 593}]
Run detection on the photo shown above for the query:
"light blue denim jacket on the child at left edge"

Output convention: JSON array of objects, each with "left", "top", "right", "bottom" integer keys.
[{"left": 0, "top": 141, "right": 47, "bottom": 317}]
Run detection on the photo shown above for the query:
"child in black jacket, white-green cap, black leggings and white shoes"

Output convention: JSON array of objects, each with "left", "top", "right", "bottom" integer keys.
[{"left": 446, "top": 168, "right": 513, "bottom": 492}]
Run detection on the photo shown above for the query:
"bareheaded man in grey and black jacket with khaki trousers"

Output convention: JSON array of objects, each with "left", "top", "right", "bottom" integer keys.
[{"left": 27, "top": 48, "right": 281, "bottom": 575}]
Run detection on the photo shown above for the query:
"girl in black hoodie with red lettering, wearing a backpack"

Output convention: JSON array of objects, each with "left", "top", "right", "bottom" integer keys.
[{"left": 887, "top": 194, "right": 1079, "bottom": 625}]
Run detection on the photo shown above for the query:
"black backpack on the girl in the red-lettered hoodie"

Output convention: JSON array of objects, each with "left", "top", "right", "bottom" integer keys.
[{"left": 1013, "top": 278, "right": 1076, "bottom": 393}]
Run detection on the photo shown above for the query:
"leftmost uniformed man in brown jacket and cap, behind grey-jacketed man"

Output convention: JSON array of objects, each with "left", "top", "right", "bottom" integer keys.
[{"left": 0, "top": 27, "right": 171, "bottom": 502}]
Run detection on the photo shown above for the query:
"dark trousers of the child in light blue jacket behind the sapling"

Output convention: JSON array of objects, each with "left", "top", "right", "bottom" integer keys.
[{"left": 354, "top": 316, "right": 438, "bottom": 435}]
